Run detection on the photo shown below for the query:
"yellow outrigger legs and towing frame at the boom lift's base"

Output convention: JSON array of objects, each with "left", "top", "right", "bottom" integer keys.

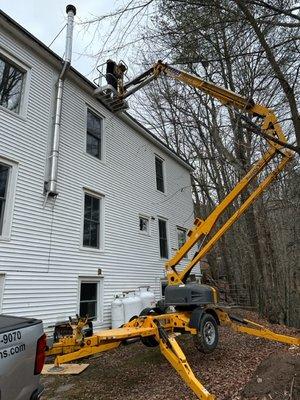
[{"left": 46, "top": 307, "right": 300, "bottom": 400}]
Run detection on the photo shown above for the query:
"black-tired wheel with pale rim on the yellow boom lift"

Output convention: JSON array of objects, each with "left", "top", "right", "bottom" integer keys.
[{"left": 194, "top": 313, "right": 219, "bottom": 354}]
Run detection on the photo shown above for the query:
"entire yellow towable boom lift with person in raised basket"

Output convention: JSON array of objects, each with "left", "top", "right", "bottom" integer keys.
[{"left": 47, "top": 60, "right": 300, "bottom": 400}]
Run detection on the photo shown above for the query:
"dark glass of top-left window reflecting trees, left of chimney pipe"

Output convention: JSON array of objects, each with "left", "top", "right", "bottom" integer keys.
[{"left": 0, "top": 56, "right": 24, "bottom": 112}]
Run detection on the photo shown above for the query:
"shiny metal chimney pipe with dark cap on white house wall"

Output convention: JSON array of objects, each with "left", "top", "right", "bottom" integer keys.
[{"left": 46, "top": 4, "right": 76, "bottom": 197}]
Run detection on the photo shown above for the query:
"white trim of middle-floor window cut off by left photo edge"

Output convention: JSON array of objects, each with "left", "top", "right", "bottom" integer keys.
[{"left": 0, "top": 157, "right": 18, "bottom": 241}]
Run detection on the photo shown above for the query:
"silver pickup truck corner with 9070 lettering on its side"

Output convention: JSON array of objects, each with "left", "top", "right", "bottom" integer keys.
[{"left": 0, "top": 314, "right": 46, "bottom": 400}]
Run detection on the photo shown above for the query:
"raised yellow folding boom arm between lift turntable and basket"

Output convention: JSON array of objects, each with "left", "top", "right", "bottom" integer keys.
[{"left": 119, "top": 61, "right": 293, "bottom": 285}]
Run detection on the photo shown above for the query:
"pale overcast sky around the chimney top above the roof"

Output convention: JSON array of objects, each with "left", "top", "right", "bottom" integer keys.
[{"left": 0, "top": 0, "right": 121, "bottom": 79}]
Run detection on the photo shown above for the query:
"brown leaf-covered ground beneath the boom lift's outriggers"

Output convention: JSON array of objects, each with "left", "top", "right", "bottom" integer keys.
[{"left": 42, "top": 312, "right": 300, "bottom": 400}]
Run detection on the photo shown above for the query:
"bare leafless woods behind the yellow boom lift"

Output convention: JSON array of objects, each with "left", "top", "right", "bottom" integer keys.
[{"left": 91, "top": 0, "right": 300, "bottom": 327}]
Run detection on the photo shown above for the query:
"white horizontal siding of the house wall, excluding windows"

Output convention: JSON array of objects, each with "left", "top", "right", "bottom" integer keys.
[{"left": 0, "top": 18, "right": 193, "bottom": 328}]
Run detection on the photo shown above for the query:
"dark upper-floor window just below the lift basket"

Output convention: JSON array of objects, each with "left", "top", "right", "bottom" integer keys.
[{"left": 86, "top": 110, "right": 103, "bottom": 160}]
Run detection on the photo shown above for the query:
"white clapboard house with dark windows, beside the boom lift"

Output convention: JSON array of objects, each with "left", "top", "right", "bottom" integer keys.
[{"left": 0, "top": 12, "right": 193, "bottom": 327}]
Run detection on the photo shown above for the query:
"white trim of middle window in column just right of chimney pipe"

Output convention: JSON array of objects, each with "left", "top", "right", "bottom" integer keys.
[{"left": 79, "top": 187, "right": 105, "bottom": 253}]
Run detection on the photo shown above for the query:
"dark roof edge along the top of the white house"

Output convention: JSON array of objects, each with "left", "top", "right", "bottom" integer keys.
[{"left": 0, "top": 10, "right": 193, "bottom": 171}]
